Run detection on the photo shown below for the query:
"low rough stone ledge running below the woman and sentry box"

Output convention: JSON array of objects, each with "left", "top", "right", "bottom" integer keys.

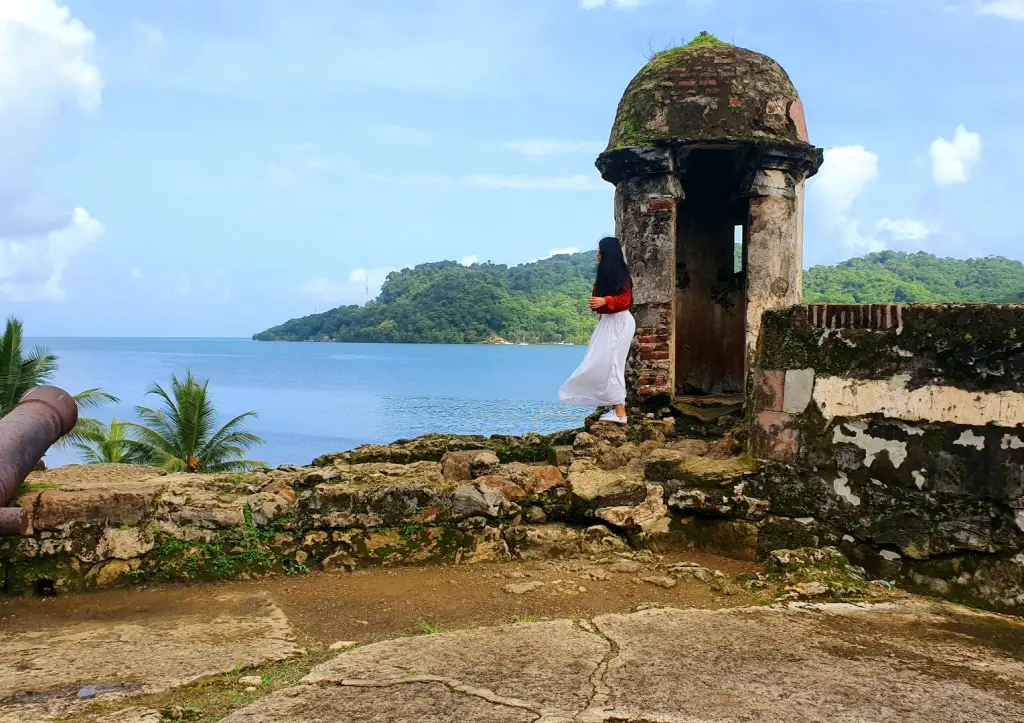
[{"left": 8, "top": 430, "right": 1024, "bottom": 611}]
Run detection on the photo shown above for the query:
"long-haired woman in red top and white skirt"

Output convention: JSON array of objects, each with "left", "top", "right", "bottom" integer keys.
[{"left": 558, "top": 237, "right": 636, "bottom": 424}]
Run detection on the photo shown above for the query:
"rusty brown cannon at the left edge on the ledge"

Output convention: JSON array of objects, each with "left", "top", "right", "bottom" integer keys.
[{"left": 0, "top": 387, "right": 78, "bottom": 535}]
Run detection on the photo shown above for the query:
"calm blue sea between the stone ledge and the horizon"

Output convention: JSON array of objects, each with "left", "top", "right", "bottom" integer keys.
[{"left": 27, "top": 338, "right": 588, "bottom": 466}]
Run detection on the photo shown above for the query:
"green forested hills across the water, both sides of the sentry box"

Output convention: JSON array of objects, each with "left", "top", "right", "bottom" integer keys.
[{"left": 253, "top": 251, "right": 1024, "bottom": 343}]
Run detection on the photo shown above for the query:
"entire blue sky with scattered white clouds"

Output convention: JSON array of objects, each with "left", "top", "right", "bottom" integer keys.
[{"left": 6, "top": 0, "right": 1024, "bottom": 337}]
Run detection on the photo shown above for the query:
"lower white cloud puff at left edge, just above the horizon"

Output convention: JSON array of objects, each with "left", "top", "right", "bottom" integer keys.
[{"left": 0, "top": 208, "right": 103, "bottom": 301}]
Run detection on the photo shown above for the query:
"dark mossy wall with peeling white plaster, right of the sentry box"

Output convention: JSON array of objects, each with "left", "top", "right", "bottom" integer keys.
[{"left": 751, "top": 305, "right": 1024, "bottom": 611}]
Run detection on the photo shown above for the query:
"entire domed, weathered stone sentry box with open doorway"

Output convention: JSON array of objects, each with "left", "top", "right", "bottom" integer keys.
[{"left": 597, "top": 34, "right": 822, "bottom": 401}]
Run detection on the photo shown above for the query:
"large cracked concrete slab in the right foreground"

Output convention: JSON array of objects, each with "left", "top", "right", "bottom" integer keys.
[{"left": 224, "top": 601, "right": 1024, "bottom": 723}]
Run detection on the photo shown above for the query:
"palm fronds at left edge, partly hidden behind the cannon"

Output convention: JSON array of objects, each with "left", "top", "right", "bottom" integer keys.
[{"left": 0, "top": 316, "right": 119, "bottom": 446}]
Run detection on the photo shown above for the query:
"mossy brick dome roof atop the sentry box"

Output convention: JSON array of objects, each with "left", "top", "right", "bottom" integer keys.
[{"left": 607, "top": 33, "right": 809, "bottom": 151}]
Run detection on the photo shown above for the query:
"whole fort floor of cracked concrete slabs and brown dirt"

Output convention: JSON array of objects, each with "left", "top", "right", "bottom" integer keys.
[{"left": 0, "top": 557, "right": 1024, "bottom": 723}]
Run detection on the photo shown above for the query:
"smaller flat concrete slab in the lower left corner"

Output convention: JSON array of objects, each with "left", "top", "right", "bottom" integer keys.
[{"left": 0, "top": 591, "right": 300, "bottom": 723}]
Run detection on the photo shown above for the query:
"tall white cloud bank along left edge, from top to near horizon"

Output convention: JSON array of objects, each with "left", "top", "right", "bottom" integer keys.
[{"left": 0, "top": 0, "right": 103, "bottom": 300}]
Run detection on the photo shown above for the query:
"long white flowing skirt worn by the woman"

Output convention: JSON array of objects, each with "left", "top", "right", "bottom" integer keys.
[{"left": 558, "top": 311, "right": 637, "bottom": 407}]
